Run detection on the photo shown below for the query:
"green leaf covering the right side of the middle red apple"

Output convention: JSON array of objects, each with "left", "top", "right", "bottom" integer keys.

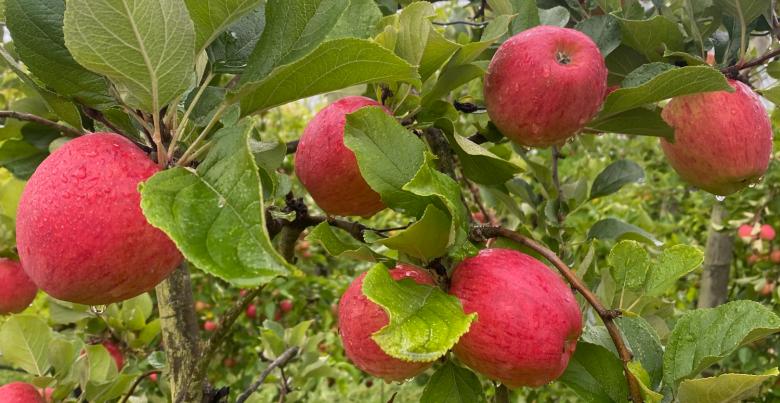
[{"left": 344, "top": 107, "right": 427, "bottom": 216}]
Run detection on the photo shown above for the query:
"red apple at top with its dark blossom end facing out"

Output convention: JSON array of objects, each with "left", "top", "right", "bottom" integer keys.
[{"left": 484, "top": 26, "right": 607, "bottom": 147}]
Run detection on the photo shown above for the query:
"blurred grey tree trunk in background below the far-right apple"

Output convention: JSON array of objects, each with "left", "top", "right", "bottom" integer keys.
[{"left": 697, "top": 202, "right": 734, "bottom": 308}]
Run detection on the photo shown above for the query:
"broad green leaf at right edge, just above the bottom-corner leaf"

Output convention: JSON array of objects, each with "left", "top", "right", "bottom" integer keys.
[{"left": 664, "top": 301, "right": 780, "bottom": 391}]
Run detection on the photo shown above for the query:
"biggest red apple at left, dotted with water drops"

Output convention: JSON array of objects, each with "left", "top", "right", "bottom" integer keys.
[{"left": 16, "top": 133, "right": 181, "bottom": 305}]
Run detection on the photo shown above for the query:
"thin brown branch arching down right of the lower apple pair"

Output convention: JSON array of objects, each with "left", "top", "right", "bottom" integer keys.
[{"left": 469, "top": 226, "right": 644, "bottom": 403}]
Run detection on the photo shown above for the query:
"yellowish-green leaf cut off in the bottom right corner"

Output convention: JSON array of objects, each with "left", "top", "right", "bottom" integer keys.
[{"left": 677, "top": 368, "right": 779, "bottom": 403}]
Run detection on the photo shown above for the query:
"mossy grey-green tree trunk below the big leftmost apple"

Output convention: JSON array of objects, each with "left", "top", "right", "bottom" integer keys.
[{"left": 157, "top": 263, "right": 204, "bottom": 403}]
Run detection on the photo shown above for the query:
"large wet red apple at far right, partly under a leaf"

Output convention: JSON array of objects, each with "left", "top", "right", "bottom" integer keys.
[{"left": 661, "top": 80, "right": 772, "bottom": 196}]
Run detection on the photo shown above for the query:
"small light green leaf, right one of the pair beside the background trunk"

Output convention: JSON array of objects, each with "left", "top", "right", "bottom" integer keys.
[{"left": 645, "top": 245, "right": 704, "bottom": 296}]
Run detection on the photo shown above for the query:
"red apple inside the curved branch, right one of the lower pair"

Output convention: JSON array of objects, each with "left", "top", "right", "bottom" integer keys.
[{"left": 450, "top": 249, "right": 582, "bottom": 388}]
